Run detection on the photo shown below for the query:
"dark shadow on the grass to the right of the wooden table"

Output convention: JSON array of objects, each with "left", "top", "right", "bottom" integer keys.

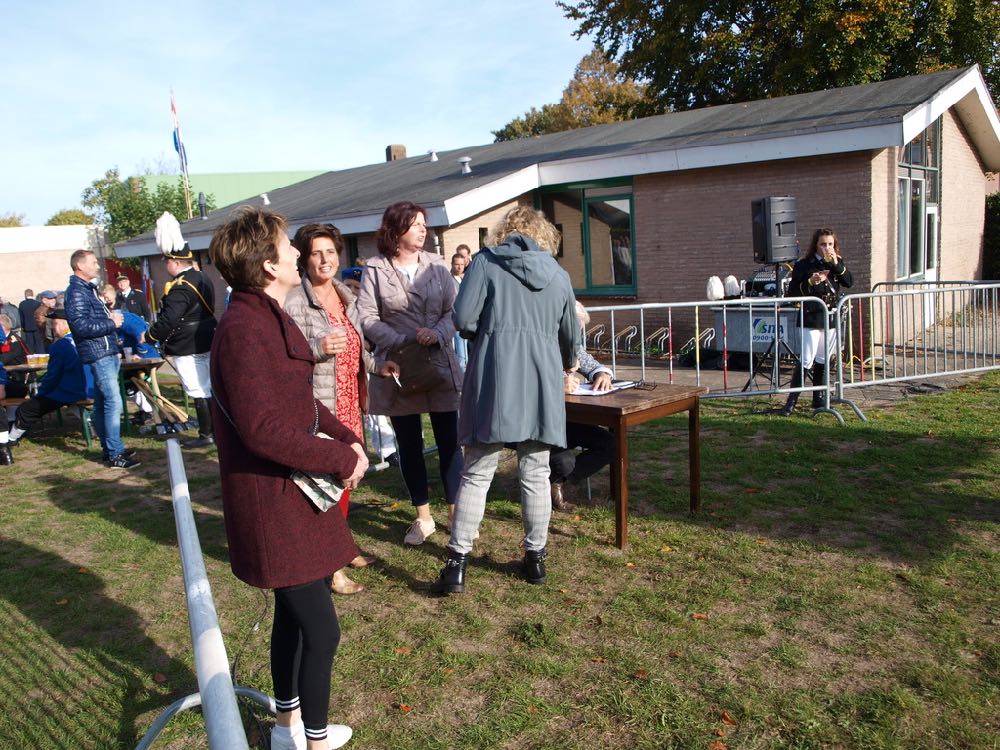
[{"left": 624, "top": 402, "right": 1000, "bottom": 563}]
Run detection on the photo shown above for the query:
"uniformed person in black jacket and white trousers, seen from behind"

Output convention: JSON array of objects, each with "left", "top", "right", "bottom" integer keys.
[{"left": 146, "top": 239, "right": 216, "bottom": 448}]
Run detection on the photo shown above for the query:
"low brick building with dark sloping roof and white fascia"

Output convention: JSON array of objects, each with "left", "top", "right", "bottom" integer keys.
[{"left": 116, "top": 66, "right": 1000, "bottom": 318}]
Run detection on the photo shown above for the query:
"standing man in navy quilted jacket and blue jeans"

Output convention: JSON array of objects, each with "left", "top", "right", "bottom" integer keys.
[{"left": 66, "top": 250, "right": 139, "bottom": 469}]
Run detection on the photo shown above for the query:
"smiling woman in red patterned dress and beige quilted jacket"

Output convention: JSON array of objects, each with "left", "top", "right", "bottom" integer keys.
[{"left": 284, "top": 224, "right": 392, "bottom": 594}]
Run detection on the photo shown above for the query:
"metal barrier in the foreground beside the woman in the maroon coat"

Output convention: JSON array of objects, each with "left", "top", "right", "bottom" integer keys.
[{"left": 136, "top": 438, "right": 277, "bottom": 750}]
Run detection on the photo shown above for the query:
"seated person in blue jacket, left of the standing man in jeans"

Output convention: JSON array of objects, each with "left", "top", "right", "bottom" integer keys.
[{"left": 9, "top": 308, "right": 94, "bottom": 444}]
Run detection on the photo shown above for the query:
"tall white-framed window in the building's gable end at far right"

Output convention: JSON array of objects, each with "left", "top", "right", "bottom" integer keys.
[{"left": 896, "top": 119, "right": 941, "bottom": 279}]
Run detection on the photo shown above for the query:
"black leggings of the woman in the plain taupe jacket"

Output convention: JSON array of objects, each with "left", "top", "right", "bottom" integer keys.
[{"left": 389, "top": 411, "right": 462, "bottom": 506}]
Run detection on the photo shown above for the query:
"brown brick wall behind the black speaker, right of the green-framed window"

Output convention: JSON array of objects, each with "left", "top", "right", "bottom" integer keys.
[{"left": 634, "top": 152, "right": 878, "bottom": 303}]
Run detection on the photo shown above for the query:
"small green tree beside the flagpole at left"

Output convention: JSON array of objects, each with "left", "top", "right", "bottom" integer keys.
[{"left": 82, "top": 167, "right": 215, "bottom": 243}]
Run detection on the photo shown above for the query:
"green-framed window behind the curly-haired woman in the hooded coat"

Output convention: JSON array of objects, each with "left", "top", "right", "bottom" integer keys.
[{"left": 537, "top": 181, "right": 636, "bottom": 295}]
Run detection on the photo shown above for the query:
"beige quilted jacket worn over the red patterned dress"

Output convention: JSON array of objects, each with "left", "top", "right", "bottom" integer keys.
[{"left": 285, "top": 276, "right": 376, "bottom": 412}]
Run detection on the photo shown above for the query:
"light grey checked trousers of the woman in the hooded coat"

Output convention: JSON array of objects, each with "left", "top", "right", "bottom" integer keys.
[{"left": 448, "top": 440, "right": 552, "bottom": 555}]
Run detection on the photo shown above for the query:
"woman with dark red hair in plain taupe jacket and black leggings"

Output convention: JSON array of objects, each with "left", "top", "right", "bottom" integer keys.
[{"left": 358, "top": 202, "right": 462, "bottom": 545}]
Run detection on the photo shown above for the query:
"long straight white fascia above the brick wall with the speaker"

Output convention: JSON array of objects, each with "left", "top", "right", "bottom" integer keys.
[{"left": 539, "top": 122, "right": 902, "bottom": 185}]
